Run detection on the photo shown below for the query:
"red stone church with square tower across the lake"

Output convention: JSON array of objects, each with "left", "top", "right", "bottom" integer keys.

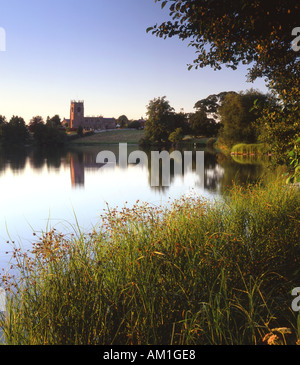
[{"left": 62, "top": 100, "right": 117, "bottom": 130}]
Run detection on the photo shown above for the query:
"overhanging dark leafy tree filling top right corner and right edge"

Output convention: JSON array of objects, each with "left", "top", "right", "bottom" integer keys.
[{"left": 147, "top": 0, "right": 300, "bottom": 159}]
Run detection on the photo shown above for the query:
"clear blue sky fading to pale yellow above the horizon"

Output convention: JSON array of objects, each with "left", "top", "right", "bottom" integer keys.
[{"left": 0, "top": 0, "right": 266, "bottom": 123}]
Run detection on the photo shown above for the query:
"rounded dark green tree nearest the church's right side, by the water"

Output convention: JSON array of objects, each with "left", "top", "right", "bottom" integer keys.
[{"left": 145, "top": 96, "right": 174, "bottom": 143}]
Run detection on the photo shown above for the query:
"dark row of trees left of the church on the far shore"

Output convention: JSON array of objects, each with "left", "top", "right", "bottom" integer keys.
[{"left": 0, "top": 115, "right": 67, "bottom": 146}]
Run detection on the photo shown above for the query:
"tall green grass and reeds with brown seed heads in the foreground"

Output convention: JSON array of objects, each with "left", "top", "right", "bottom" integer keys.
[{"left": 0, "top": 181, "right": 300, "bottom": 345}]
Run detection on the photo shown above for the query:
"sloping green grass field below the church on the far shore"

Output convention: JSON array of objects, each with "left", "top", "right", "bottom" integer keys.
[{"left": 70, "top": 129, "right": 144, "bottom": 145}]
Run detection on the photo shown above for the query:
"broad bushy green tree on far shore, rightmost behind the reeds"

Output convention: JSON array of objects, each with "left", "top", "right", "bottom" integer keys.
[{"left": 219, "top": 90, "right": 268, "bottom": 148}]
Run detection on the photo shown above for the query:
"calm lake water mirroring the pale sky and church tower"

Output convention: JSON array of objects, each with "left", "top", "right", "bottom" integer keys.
[{"left": 0, "top": 146, "right": 264, "bottom": 267}]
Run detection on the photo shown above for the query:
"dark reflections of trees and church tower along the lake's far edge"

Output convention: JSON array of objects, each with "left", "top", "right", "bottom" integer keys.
[{"left": 0, "top": 145, "right": 266, "bottom": 194}]
